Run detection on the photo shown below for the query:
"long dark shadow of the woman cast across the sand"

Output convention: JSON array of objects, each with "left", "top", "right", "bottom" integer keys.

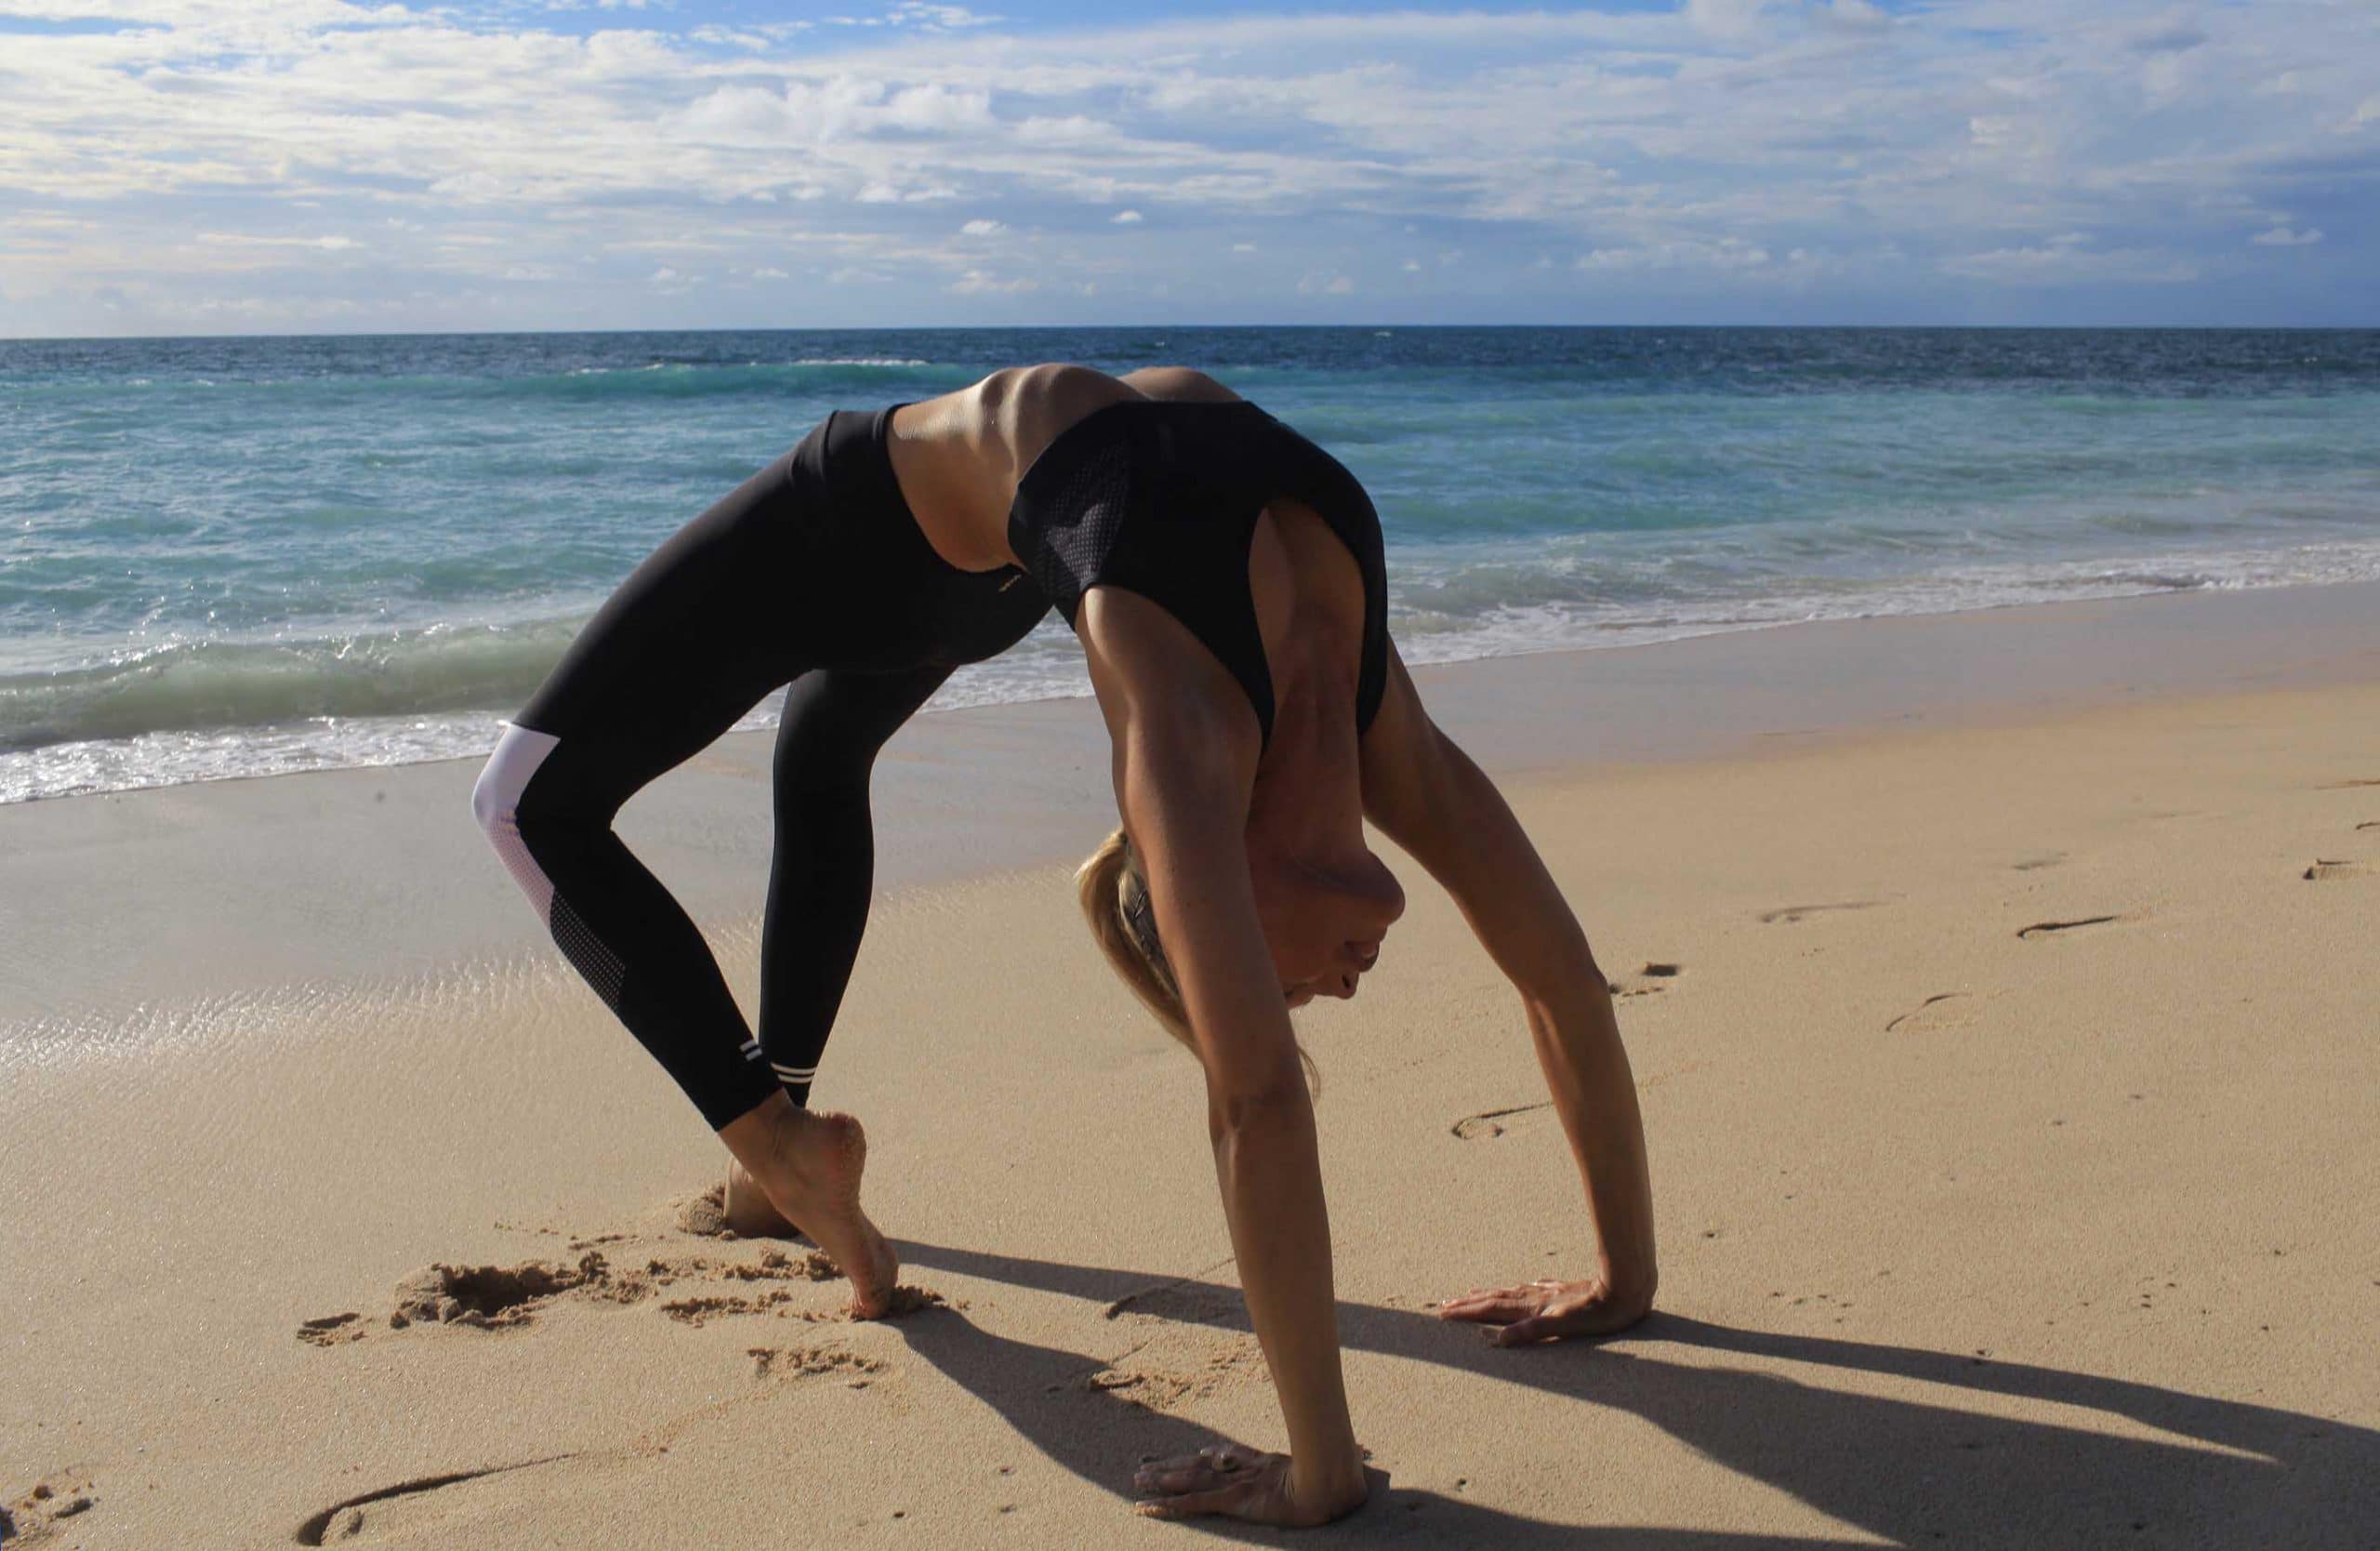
[{"left": 900, "top": 1241, "right": 2380, "bottom": 1551}]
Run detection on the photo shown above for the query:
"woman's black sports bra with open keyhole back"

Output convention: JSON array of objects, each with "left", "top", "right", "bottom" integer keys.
[{"left": 1009, "top": 400, "right": 1387, "bottom": 745}]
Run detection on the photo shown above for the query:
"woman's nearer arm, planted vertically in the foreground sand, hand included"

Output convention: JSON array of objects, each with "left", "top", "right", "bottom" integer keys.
[{"left": 1080, "top": 588, "right": 1366, "bottom": 1525}]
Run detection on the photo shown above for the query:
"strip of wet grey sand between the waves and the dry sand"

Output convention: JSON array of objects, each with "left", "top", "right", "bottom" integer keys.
[{"left": 0, "top": 568, "right": 2380, "bottom": 1027}]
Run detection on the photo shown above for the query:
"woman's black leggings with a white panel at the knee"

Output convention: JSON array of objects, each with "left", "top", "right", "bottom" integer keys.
[{"left": 471, "top": 409, "right": 1047, "bottom": 1130}]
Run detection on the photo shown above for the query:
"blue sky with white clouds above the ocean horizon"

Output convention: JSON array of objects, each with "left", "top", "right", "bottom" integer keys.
[{"left": 0, "top": 0, "right": 2380, "bottom": 338}]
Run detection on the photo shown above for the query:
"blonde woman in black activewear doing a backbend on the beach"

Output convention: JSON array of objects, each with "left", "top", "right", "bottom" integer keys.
[{"left": 471, "top": 366, "right": 1654, "bottom": 1525}]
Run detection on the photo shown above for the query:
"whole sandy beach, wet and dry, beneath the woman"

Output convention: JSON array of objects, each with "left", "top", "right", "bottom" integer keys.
[{"left": 0, "top": 588, "right": 2380, "bottom": 1548}]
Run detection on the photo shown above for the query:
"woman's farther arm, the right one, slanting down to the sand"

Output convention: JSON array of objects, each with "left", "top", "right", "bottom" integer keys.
[{"left": 1364, "top": 652, "right": 1657, "bottom": 1344}]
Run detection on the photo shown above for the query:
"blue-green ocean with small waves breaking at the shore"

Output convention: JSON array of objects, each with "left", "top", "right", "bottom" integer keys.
[{"left": 0, "top": 328, "right": 2380, "bottom": 802}]
